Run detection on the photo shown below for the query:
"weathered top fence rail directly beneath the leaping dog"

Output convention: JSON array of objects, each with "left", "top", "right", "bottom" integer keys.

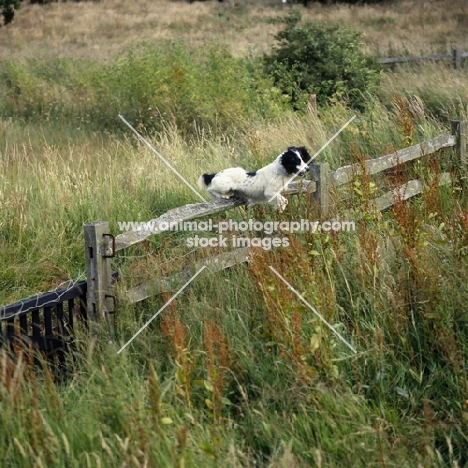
[{"left": 115, "top": 180, "right": 315, "bottom": 251}]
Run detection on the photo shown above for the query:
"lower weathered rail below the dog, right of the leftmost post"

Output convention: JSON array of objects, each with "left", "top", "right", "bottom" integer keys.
[{"left": 125, "top": 247, "right": 250, "bottom": 303}]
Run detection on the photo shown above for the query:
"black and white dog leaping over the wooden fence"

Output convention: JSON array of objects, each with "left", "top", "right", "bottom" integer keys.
[{"left": 198, "top": 146, "right": 311, "bottom": 212}]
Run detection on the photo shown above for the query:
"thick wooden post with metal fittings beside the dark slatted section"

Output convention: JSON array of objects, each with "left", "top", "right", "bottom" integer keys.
[{"left": 84, "top": 221, "right": 115, "bottom": 330}]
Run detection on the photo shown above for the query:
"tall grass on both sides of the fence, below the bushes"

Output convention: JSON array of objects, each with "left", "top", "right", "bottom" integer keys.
[{"left": 0, "top": 90, "right": 468, "bottom": 467}]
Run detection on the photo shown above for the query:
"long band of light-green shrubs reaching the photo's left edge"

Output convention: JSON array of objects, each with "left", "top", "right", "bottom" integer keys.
[{"left": 0, "top": 42, "right": 287, "bottom": 134}]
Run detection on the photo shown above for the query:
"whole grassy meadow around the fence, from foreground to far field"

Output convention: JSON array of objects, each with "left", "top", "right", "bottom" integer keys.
[{"left": 0, "top": 0, "right": 468, "bottom": 468}]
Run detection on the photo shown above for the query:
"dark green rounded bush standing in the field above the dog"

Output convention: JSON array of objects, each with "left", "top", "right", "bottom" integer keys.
[{"left": 264, "top": 10, "right": 379, "bottom": 109}]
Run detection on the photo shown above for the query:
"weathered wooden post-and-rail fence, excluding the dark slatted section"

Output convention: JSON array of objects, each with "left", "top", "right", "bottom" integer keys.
[{"left": 84, "top": 121, "right": 467, "bottom": 328}]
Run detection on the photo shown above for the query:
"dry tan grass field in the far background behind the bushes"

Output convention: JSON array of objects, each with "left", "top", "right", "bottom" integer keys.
[{"left": 0, "top": 0, "right": 468, "bottom": 59}]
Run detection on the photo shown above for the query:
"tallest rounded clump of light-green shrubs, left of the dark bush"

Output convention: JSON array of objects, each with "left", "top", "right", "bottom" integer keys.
[{"left": 99, "top": 42, "right": 288, "bottom": 133}]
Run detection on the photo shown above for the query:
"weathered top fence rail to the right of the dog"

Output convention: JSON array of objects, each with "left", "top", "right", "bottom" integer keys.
[{"left": 330, "top": 134, "right": 456, "bottom": 187}]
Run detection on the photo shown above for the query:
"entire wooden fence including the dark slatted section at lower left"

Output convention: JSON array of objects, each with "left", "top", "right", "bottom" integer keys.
[{"left": 0, "top": 121, "right": 467, "bottom": 351}]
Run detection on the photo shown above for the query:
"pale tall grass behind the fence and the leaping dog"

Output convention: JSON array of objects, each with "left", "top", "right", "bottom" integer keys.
[{"left": 0, "top": 89, "right": 446, "bottom": 302}]
